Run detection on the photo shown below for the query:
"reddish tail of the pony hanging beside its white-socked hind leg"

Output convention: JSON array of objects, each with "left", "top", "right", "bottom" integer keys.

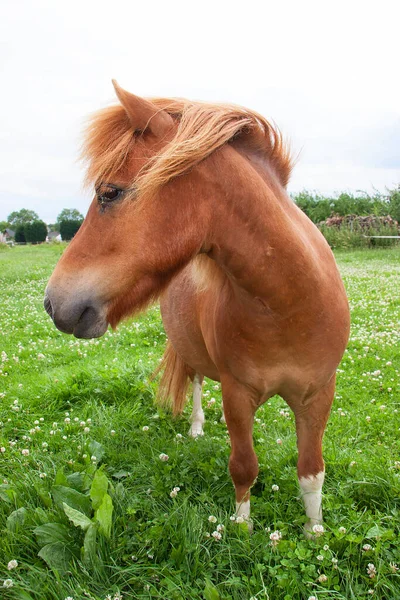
[{"left": 154, "top": 342, "right": 194, "bottom": 415}]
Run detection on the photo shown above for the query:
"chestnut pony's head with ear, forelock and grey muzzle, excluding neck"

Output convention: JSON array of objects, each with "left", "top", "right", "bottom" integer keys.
[{"left": 44, "top": 82, "right": 184, "bottom": 338}]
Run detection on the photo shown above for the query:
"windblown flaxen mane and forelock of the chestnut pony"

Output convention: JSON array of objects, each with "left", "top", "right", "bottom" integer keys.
[{"left": 82, "top": 98, "right": 292, "bottom": 195}]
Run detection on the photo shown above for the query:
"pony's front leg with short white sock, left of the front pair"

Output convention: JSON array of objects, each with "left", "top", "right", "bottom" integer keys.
[{"left": 221, "top": 376, "right": 258, "bottom": 520}]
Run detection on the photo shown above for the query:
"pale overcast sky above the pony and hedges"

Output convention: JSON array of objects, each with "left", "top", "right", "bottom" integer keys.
[{"left": 0, "top": 0, "right": 400, "bottom": 223}]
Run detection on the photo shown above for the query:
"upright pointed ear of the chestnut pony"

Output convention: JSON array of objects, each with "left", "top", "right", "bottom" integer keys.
[{"left": 112, "top": 79, "right": 174, "bottom": 137}]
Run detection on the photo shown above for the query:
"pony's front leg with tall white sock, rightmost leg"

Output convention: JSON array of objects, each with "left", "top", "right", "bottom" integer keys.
[{"left": 292, "top": 376, "right": 335, "bottom": 532}]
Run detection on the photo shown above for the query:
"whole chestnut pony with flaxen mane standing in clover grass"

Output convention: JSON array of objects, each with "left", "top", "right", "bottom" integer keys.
[{"left": 45, "top": 82, "right": 349, "bottom": 530}]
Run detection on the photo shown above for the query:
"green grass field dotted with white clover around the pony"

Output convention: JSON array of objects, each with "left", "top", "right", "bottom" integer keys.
[{"left": 0, "top": 246, "right": 400, "bottom": 600}]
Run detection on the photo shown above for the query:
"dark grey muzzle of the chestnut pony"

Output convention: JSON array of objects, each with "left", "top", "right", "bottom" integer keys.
[{"left": 44, "top": 288, "right": 108, "bottom": 338}]
